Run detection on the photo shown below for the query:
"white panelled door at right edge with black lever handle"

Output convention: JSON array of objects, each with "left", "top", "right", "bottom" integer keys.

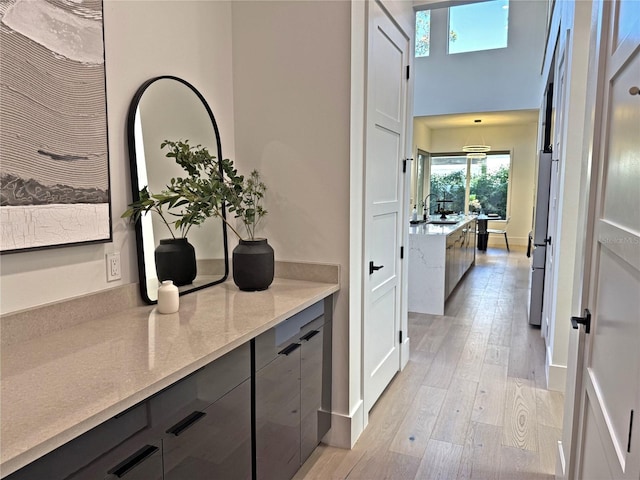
[{"left": 574, "top": 0, "right": 640, "bottom": 480}]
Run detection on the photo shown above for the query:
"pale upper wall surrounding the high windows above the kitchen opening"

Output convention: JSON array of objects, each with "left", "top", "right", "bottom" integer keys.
[{"left": 414, "top": 0, "right": 547, "bottom": 116}]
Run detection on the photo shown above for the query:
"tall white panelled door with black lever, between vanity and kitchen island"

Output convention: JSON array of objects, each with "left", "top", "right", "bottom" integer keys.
[{"left": 362, "top": 2, "right": 409, "bottom": 412}]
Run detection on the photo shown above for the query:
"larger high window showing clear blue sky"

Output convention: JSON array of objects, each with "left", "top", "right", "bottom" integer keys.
[{"left": 448, "top": 0, "right": 509, "bottom": 54}]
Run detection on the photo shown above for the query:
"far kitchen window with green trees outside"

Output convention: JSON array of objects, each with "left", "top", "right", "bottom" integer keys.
[{"left": 429, "top": 152, "right": 511, "bottom": 218}]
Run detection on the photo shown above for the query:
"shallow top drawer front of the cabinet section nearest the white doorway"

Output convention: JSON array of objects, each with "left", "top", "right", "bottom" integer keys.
[{"left": 255, "top": 300, "right": 324, "bottom": 370}]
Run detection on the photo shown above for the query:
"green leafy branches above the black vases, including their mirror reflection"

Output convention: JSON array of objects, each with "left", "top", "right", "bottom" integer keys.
[{"left": 121, "top": 140, "right": 267, "bottom": 240}]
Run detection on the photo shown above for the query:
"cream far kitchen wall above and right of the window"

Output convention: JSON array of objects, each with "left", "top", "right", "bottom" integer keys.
[{"left": 415, "top": 123, "right": 538, "bottom": 246}]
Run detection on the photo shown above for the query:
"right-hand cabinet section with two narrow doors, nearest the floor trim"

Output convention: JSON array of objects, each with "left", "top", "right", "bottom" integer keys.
[{"left": 255, "top": 302, "right": 331, "bottom": 480}]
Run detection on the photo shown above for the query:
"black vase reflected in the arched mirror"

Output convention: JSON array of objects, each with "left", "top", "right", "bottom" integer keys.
[{"left": 155, "top": 238, "right": 197, "bottom": 286}]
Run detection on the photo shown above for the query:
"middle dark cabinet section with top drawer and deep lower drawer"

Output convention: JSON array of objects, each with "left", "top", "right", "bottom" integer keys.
[{"left": 156, "top": 343, "right": 251, "bottom": 480}]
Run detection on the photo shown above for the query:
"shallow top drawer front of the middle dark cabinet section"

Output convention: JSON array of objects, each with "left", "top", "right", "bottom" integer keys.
[{"left": 149, "top": 343, "right": 251, "bottom": 424}]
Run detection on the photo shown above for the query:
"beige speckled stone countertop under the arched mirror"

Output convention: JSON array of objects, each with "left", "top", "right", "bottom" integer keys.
[{"left": 0, "top": 278, "right": 339, "bottom": 476}]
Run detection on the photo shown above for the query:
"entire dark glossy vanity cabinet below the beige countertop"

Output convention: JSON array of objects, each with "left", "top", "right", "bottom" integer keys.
[{"left": 3, "top": 297, "right": 331, "bottom": 480}]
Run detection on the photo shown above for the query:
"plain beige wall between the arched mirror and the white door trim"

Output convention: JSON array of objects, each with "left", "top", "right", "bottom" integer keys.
[{"left": 232, "top": 1, "right": 352, "bottom": 446}]
